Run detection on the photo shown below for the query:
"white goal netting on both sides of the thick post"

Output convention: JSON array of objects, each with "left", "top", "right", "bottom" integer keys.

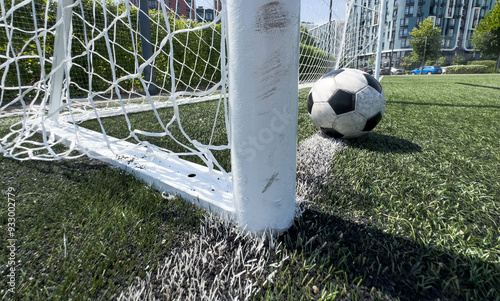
[{"left": 0, "top": 0, "right": 373, "bottom": 170}]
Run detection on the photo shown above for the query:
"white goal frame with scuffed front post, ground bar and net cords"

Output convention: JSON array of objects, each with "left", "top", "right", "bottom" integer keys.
[{"left": 2, "top": 0, "right": 300, "bottom": 232}]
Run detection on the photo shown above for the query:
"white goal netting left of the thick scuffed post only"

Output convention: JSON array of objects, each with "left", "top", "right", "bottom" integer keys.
[{"left": 0, "top": 0, "right": 228, "bottom": 168}]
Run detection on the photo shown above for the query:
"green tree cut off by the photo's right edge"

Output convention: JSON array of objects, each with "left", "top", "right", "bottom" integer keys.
[{"left": 472, "top": 1, "right": 500, "bottom": 73}]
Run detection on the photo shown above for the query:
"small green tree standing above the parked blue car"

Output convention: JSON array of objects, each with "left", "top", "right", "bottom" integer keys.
[{"left": 409, "top": 18, "right": 443, "bottom": 71}]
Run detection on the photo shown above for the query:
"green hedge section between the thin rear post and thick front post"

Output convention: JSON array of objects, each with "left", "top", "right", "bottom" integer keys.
[{"left": 71, "top": 2, "right": 221, "bottom": 96}]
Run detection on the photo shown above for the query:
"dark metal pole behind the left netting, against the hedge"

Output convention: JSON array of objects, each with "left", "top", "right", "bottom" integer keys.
[{"left": 139, "top": 0, "right": 157, "bottom": 95}]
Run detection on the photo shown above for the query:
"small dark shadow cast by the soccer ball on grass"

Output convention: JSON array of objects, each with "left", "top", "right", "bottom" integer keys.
[{"left": 347, "top": 132, "right": 422, "bottom": 154}]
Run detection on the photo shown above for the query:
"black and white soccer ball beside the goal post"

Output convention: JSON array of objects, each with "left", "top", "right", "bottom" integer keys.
[{"left": 307, "top": 69, "right": 385, "bottom": 138}]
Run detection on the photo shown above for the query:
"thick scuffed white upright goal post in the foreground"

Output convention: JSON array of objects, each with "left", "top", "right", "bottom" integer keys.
[{"left": 227, "top": 0, "right": 300, "bottom": 232}]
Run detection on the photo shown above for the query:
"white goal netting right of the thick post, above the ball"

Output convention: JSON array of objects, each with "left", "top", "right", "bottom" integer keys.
[{"left": 300, "top": 0, "right": 387, "bottom": 72}]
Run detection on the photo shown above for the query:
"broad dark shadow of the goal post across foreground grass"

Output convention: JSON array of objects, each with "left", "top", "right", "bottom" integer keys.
[{"left": 280, "top": 209, "right": 500, "bottom": 300}]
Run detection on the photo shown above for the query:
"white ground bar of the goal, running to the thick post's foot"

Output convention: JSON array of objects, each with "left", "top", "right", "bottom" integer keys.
[{"left": 39, "top": 122, "right": 234, "bottom": 219}]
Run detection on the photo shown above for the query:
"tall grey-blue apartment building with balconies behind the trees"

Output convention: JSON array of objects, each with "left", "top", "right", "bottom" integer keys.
[{"left": 346, "top": 0, "right": 495, "bottom": 67}]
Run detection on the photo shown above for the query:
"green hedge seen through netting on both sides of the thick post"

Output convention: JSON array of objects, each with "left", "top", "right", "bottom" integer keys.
[{"left": 0, "top": 0, "right": 335, "bottom": 100}]
